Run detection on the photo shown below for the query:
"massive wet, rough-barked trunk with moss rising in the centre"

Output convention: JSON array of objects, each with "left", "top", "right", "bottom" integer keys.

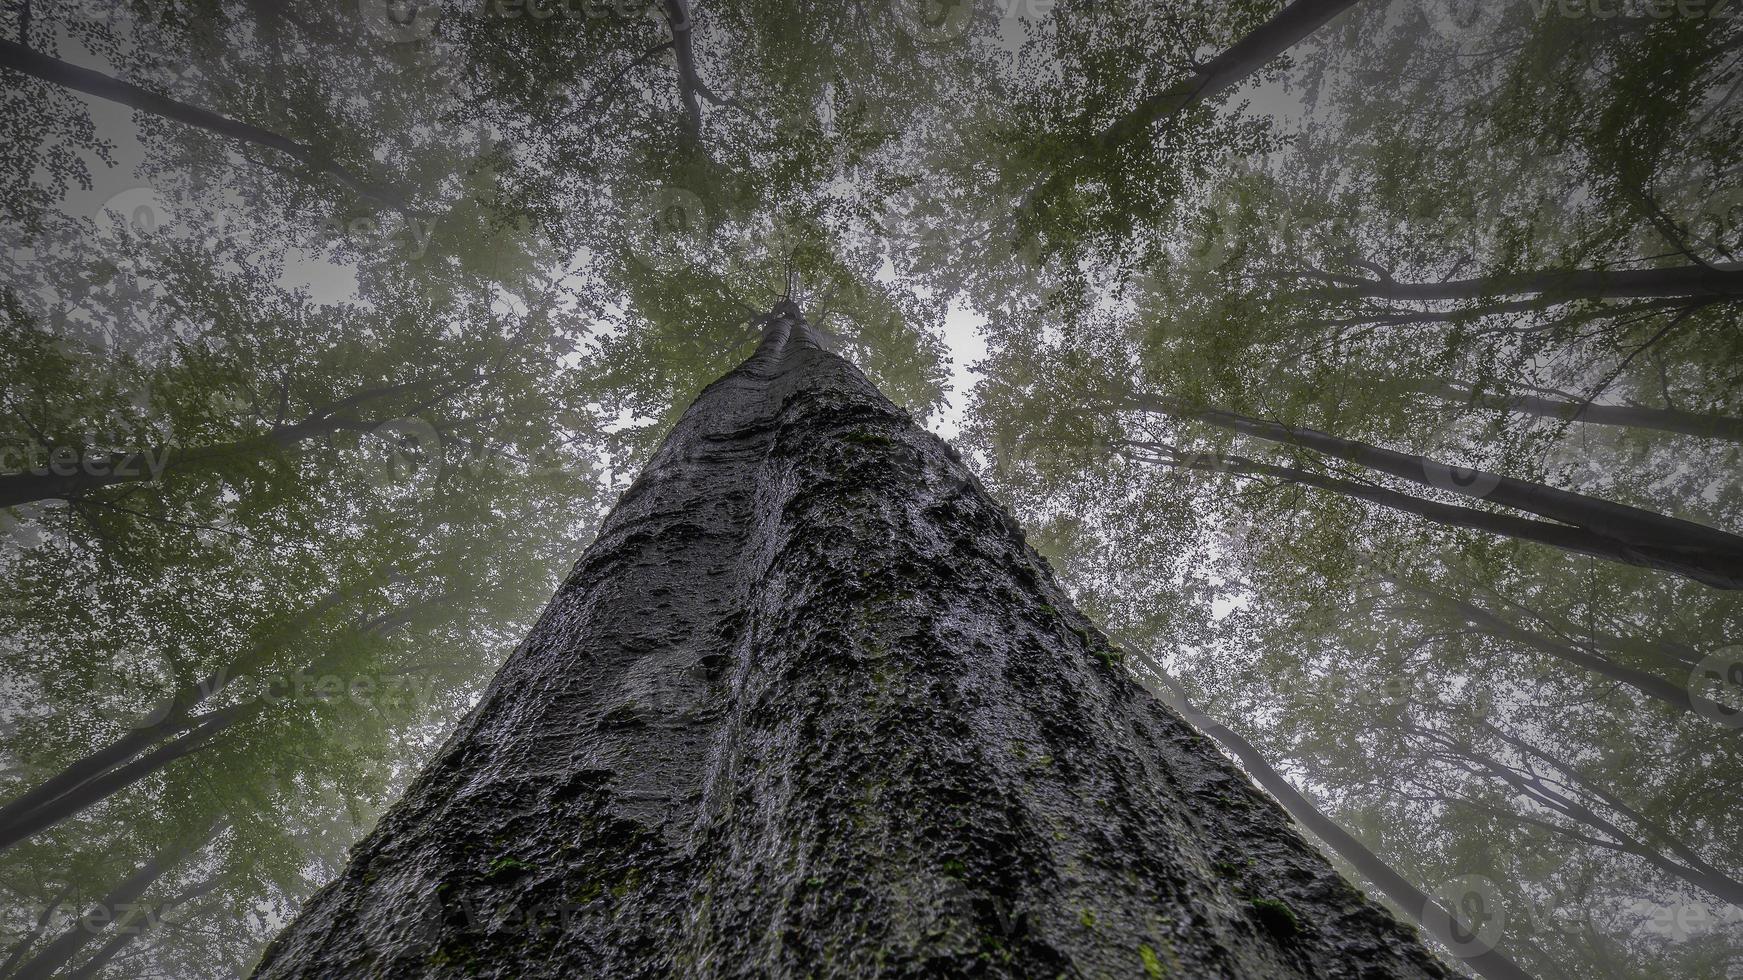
[{"left": 245, "top": 305, "right": 1447, "bottom": 978}]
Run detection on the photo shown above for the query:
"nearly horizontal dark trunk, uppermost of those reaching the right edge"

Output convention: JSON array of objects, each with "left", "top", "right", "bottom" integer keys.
[{"left": 1314, "top": 265, "right": 1743, "bottom": 302}]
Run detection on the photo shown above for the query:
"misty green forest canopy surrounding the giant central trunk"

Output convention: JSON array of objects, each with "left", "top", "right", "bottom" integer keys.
[{"left": 0, "top": 0, "right": 1743, "bottom": 978}]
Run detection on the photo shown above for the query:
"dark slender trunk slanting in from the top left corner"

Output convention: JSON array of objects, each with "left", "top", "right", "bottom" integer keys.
[{"left": 0, "top": 40, "right": 404, "bottom": 209}]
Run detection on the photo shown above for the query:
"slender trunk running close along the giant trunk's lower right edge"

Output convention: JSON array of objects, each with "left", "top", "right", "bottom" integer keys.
[{"left": 1126, "top": 643, "right": 1530, "bottom": 980}]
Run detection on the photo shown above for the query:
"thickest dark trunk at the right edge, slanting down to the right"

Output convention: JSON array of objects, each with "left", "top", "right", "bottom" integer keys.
[{"left": 1129, "top": 396, "right": 1743, "bottom": 589}]
